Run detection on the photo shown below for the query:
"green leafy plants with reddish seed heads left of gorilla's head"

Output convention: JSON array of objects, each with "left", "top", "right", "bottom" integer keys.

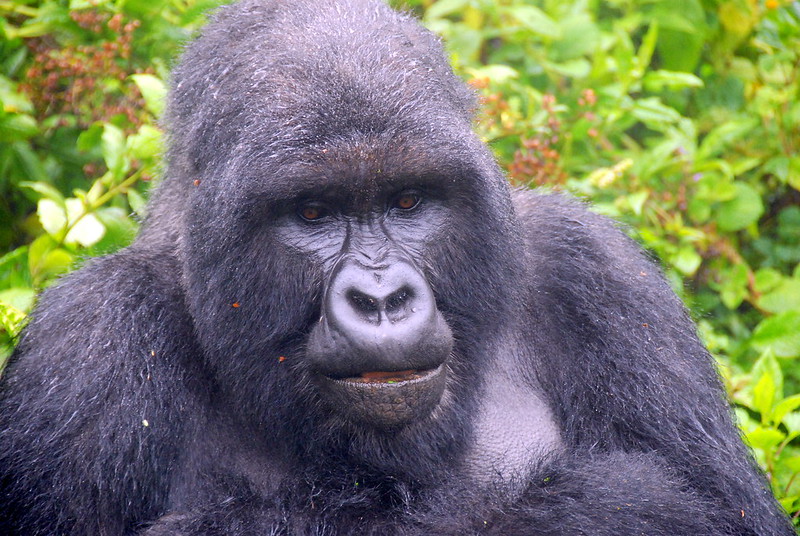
[{"left": 0, "top": 0, "right": 218, "bottom": 367}]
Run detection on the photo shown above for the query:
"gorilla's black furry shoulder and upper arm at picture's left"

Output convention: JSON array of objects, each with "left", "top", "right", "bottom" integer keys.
[{"left": 0, "top": 248, "right": 200, "bottom": 535}]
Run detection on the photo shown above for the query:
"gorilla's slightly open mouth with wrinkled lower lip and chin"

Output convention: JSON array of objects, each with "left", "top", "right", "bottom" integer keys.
[{"left": 318, "top": 363, "right": 447, "bottom": 429}]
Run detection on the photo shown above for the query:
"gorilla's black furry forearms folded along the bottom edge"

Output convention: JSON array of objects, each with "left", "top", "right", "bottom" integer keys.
[{"left": 134, "top": 453, "right": 728, "bottom": 536}]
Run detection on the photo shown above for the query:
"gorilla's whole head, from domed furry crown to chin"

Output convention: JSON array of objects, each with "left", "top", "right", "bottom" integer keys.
[{"left": 150, "top": 1, "right": 522, "bottom": 476}]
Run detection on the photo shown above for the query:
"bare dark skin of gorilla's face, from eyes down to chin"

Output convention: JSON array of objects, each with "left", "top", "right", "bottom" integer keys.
[{"left": 277, "top": 175, "right": 453, "bottom": 428}]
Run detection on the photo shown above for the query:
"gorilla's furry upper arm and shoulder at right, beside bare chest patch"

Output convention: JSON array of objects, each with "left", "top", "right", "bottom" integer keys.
[{"left": 515, "top": 191, "right": 793, "bottom": 534}]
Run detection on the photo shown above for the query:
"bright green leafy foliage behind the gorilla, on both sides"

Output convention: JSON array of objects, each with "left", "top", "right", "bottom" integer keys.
[{"left": 0, "top": 0, "right": 800, "bottom": 519}]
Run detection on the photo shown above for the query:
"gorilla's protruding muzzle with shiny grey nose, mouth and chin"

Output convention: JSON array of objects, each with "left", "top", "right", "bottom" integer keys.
[{"left": 307, "top": 260, "right": 453, "bottom": 429}]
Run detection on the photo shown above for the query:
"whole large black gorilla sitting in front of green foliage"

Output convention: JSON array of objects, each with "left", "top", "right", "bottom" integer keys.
[{"left": 0, "top": 0, "right": 793, "bottom": 536}]
